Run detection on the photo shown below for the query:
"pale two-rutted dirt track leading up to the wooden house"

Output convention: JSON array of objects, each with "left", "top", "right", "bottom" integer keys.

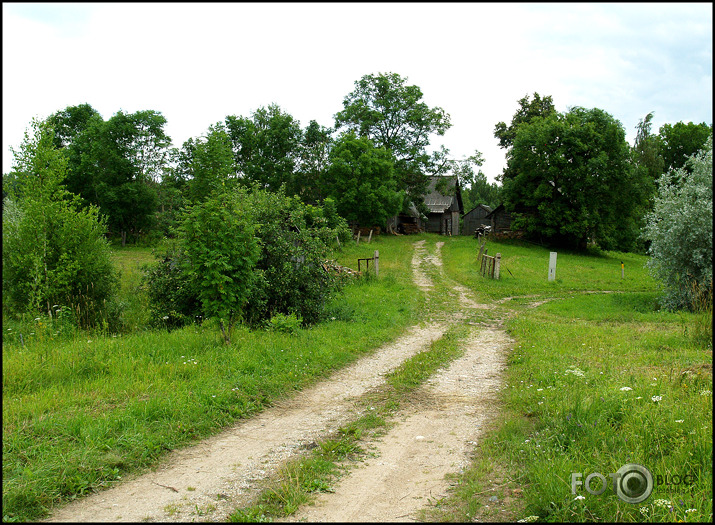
[{"left": 47, "top": 237, "right": 510, "bottom": 522}]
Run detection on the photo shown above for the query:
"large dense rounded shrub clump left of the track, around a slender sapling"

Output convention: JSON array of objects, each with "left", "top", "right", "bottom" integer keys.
[{"left": 145, "top": 186, "right": 351, "bottom": 327}]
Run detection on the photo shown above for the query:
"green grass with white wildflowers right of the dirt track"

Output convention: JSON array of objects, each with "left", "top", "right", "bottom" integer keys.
[{"left": 430, "top": 235, "right": 712, "bottom": 522}]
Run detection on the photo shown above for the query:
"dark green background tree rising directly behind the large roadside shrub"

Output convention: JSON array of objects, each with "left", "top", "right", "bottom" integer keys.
[{"left": 225, "top": 104, "right": 302, "bottom": 195}]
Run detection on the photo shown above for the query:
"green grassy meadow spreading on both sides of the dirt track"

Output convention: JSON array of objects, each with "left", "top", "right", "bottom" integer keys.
[{"left": 3, "top": 234, "right": 712, "bottom": 522}]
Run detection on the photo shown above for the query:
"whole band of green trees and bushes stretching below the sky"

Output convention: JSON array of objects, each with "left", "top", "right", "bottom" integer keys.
[{"left": 3, "top": 73, "right": 712, "bottom": 332}]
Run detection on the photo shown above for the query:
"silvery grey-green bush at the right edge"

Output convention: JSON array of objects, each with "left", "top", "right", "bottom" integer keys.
[{"left": 643, "top": 137, "right": 713, "bottom": 309}]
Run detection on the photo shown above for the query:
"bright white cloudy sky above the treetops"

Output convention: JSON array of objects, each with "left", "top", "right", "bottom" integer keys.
[{"left": 2, "top": 2, "right": 713, "bottom": 181}]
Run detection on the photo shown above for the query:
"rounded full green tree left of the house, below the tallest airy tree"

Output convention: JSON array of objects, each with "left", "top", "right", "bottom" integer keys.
[{"left": 322, "top": 131, "right": 404, "bottom": 227}]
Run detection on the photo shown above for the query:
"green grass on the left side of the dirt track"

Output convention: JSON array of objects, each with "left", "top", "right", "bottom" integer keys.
[{"left": 3, "top": 238, "right": 420, "bottom": 521}]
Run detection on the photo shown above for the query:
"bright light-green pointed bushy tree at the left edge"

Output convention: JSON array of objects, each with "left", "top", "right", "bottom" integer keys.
[{"left": 3, "top": 120, "right": 117, "bottom": 326}]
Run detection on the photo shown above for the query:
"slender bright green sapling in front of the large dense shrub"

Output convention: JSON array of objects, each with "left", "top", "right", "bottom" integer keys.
[{"left": 180, "top": 192, "right": 260, "bottom": 344}]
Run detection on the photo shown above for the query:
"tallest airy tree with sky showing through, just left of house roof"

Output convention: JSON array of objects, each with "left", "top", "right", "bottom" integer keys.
[{"left": 335, "top": 73, "right": 451, "bottom": 209}]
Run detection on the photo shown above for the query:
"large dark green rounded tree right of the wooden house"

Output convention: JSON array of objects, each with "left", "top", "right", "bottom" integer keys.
[{"left": 503, "top": 107, "right": 646, "bottom": 250}]
